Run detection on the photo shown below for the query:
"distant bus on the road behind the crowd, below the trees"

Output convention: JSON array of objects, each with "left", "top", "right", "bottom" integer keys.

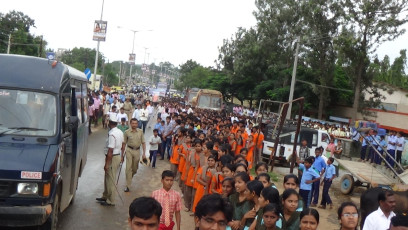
[{"left": 192, "top": 89, "right": 223, "bottom": 110}]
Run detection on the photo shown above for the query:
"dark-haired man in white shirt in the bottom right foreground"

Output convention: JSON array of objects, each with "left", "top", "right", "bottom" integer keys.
[{"left": 363, "top": 190, "right": 396, "bottom": 230}]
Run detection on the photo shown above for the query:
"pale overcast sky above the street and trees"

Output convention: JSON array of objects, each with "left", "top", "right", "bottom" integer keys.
[{"left": 0, "top": 0, "right": 408, "bottom": 66}]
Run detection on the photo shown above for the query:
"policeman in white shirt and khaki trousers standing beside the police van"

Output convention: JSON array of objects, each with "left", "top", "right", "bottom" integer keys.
[{"left": 96, "top": 114, "right": 123, "bottom": 206}]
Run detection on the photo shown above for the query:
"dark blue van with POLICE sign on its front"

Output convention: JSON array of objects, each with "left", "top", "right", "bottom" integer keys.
[{"left": 0, "top": 54, "right": 89, "bottom": 230}]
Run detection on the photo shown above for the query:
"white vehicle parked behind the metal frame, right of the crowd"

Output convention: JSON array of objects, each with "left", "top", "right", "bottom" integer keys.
[{"left": 262, "top": 124, "right": 330, "bottom": 166}]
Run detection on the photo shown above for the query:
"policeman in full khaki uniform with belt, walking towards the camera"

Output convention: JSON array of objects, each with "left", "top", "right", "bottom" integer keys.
[{"left": 122, "top": 118, "right": 146, "bottom": 192}]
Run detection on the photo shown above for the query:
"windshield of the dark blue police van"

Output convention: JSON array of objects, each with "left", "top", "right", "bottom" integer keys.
[{"left": 0, "top": 89, "right": 57, "bottom": 136}]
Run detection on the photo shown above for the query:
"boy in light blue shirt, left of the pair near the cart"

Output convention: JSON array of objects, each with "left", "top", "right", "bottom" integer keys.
[{"left": 299, "top": 157, "right": 320, "bottom": 208}]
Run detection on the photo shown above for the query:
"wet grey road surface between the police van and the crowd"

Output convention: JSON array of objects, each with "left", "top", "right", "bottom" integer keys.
[{"left": 58, "top": 123, "right": 194, "bottom": 230}]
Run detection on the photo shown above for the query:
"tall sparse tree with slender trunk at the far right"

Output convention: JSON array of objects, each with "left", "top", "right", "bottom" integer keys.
[{"left": 338, "top": 0, "right": 408, "bottom": 121}]
